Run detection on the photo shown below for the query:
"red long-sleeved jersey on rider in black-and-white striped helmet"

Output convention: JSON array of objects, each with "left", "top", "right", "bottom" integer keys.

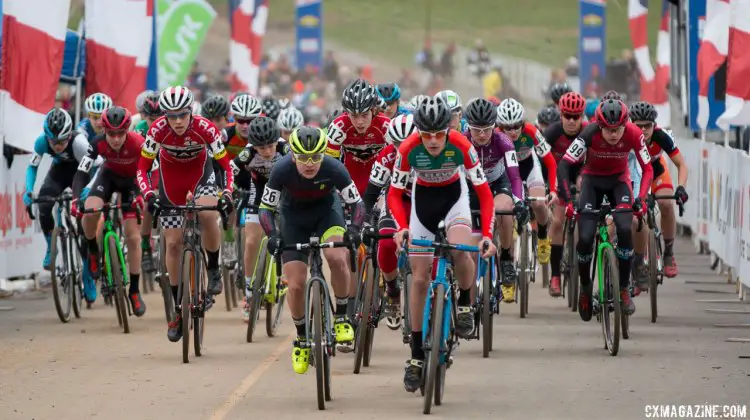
[{"left": 137, "top": 115, "right": 234, "bottom": 207}]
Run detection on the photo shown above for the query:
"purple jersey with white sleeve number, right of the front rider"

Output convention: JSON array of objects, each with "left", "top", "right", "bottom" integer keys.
[{"left": 464, "top": 130, "right": 523, "bottom": 199}]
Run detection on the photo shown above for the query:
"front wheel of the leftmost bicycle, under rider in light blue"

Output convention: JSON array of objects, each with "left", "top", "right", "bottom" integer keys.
[{"left": 49, "top": 227, "right": 73, "bottom": 323}]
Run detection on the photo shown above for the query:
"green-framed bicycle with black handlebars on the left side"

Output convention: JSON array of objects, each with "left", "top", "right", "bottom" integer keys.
[{"left": 81, "top": 200, "right": 141, "bottom": 334}]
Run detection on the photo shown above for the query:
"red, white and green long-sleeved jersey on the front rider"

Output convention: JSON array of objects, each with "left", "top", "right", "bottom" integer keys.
[{"left": 387, "top": 130, "right": 495, "bottom": 237}]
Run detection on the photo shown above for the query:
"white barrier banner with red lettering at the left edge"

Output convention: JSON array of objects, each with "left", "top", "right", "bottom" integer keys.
[{"left": 0, "top": 155, "right": 50, "bottom": 278}]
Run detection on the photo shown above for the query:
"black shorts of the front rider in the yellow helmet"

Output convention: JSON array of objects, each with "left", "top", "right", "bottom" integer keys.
[{"left": 279, "top": 200, "right": 346, "bottom": 264}]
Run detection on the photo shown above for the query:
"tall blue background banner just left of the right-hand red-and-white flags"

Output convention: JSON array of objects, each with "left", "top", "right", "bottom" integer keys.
[{"left": 578, "top": 0, "right": 607, "bottom": 96}]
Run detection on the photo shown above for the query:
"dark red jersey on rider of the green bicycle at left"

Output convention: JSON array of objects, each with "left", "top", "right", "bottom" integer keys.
[{"left": 73, "top": 131, "right": 145, "bottom": 198}]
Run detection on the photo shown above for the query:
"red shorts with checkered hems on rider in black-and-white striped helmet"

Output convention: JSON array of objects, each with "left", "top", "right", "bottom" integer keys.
[{"left": 159, "top": 155, "right": 218, "bottom": 229}]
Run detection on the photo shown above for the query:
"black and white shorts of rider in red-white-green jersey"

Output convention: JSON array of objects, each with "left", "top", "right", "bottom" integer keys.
[{"left": 409, "top": 172, "right": 471, "bottom": 257}]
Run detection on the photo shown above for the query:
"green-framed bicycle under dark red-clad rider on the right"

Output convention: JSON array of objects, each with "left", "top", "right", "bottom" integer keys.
[{"left": 576, "top": 203, "right": 633, "bottom": 356}]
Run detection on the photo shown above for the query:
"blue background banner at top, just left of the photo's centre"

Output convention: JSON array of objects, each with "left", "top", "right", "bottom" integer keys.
[{"left": 295, "top": 0, "right": 323, "bottom": 69}]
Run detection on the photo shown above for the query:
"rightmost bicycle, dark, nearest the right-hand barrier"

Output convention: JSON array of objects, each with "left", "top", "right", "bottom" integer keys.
[{"left": 646, "top": 194, "right": 685, "bottom": 323}]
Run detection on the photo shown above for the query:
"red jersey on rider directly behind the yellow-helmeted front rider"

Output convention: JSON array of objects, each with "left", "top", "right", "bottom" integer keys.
[{"left": 326, "top": 113, "right": 390, "bottom": 195}]
